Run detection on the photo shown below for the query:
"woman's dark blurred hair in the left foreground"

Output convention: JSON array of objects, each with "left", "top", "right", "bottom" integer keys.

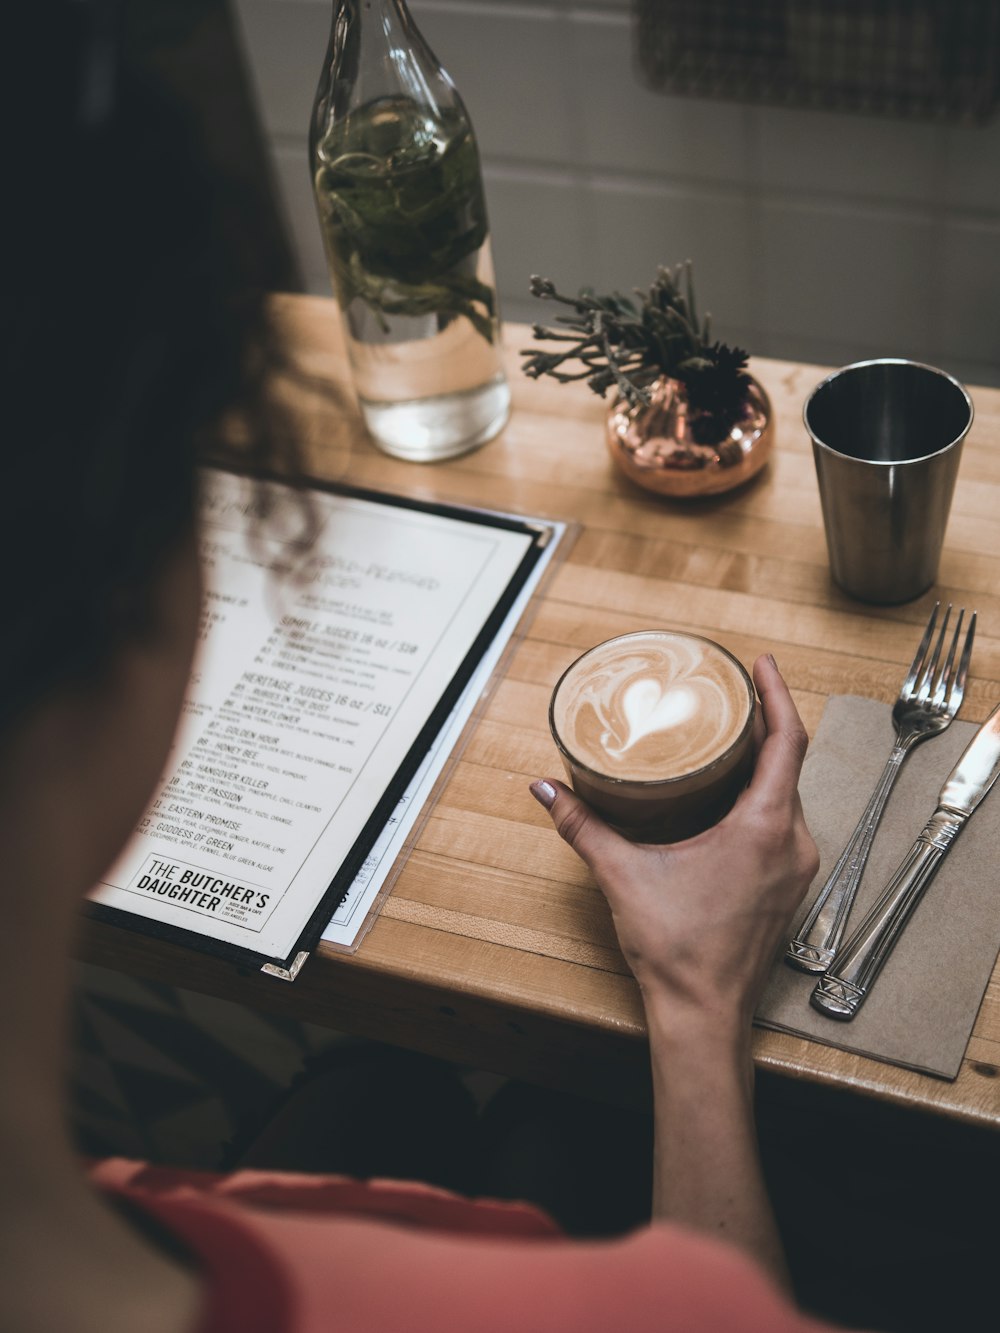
[{"left": 0, "top": 0, "right": 305, "bottom": 732}]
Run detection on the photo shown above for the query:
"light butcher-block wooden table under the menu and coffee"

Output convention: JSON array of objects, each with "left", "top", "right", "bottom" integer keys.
[{"left": 81, "top": 297, "right": 1000, "bottom": 1128}]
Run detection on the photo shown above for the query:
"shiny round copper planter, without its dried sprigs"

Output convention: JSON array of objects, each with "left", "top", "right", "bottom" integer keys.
[{"left": 607, "top": 376, "right": 775, "bottom": 499}]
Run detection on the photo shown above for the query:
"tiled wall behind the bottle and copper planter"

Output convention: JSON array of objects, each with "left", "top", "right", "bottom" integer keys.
[{"left": 235, "top": 0, "right": 1000, "bottom": 384}]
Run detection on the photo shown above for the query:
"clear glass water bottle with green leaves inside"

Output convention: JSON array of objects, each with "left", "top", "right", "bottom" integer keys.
[{"left": 309, "top": 0, "right": 511, "bottom": 463}]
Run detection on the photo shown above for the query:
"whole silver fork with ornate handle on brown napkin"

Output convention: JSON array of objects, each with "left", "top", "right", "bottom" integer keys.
[{"left": 785, "top": 603, "right": 976, "bottom": 972}]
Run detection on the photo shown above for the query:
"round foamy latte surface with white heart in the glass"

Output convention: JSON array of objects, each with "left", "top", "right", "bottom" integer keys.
[{"left": 552, "top": 631, "right": 751, "bottom": 782}]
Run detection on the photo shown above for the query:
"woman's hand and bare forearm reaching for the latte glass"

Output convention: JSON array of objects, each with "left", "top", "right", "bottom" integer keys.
[{"left": 532, "top": 657, "right": 817, "bottom": 1284}]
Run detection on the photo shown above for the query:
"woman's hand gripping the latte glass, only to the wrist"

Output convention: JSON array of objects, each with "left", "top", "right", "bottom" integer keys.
[{"left": 532, "top": 657, "right": 817, "bottom": 1033}]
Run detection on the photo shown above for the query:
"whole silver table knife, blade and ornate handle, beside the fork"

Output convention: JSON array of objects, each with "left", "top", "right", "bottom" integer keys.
[{"left": 811, "top": 704, "right": 1000, "bottom": 1020}]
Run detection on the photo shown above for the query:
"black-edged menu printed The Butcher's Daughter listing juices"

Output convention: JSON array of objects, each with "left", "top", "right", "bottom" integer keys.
[{"left": 91, "top": 471, "right": 552, "bottom": 974}]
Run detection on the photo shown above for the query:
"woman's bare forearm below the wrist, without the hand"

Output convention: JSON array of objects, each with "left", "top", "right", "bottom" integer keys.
[{"left": 647, "top": 1004, "right": 788, "bottom": 1286}]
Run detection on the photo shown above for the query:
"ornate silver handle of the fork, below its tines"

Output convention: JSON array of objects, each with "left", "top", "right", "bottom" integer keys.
[{"left": 785, "top": 740, "right": 913, "bottom": 973}]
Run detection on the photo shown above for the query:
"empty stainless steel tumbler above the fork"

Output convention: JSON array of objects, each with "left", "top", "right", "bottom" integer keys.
[{"left": 803, "top": 359, "right": 972, "bottom": 604}]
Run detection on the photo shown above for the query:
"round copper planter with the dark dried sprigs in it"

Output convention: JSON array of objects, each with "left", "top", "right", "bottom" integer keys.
[{"left": 521, "top": 261, "right": 772, "bottom": 496}]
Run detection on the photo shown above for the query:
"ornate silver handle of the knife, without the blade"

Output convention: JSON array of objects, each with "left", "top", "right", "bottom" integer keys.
[{"left": 809, "top": 809, "right": 968, "bottom": 1020}]
